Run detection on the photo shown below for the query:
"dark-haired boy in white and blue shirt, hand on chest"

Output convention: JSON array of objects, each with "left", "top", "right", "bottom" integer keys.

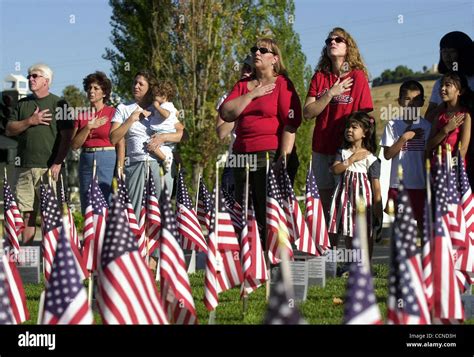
[{"left": 380, "top": 80, "right": 431, "bottom": 229}]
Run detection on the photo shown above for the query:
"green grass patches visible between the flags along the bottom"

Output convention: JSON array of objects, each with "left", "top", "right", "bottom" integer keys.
[{"left": 25, "top": 264, "right": 474, "bottom": 325}]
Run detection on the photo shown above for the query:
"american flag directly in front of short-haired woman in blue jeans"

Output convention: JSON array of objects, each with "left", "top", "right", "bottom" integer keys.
[{"left": 82, "top": 176, "right": 109, "bottom": 271}]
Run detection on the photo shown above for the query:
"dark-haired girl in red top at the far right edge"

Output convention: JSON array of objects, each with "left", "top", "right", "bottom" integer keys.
[{"left": 427, "top": 72, "right": 471, "bottom": 158}]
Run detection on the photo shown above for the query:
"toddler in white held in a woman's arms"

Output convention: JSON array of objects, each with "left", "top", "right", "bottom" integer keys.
[{"left": 150, "top": 81, "right": 178, "bottom": 172}]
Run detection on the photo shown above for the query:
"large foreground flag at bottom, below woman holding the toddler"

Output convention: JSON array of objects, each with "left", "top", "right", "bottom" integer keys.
[{"left": 97, "top": 189, "right": 167, "bottom": 325}]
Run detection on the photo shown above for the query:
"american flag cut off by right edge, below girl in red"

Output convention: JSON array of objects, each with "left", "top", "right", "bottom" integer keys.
[{"left": 456, "top": 150, "right": 474, "bottom": 284}]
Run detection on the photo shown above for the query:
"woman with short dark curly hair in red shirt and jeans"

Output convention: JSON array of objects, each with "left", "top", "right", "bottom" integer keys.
[{"left": 71, "top": 72, "right": 120, "bottom": 214}]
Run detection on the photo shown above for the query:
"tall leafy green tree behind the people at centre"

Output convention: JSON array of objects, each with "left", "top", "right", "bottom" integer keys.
[{"left": 104, "top": 0, "right": 311, "bottom": 192}]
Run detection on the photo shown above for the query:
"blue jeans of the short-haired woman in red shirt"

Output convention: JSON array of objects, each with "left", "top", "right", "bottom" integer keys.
[{"left": 79, "top": 150, "right": 117, "bottom": 214}]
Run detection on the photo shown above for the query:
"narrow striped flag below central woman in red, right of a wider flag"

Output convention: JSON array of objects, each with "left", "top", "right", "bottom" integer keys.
[{"left": 240, "top": 200, "right": 268, "bottom": 297}]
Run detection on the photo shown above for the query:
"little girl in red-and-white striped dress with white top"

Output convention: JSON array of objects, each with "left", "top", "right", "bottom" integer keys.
[{"left": 329, "top": 112, "right": 382, "bottom": 258}]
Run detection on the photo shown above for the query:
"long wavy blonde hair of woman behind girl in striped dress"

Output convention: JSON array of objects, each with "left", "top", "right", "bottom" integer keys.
[{"left": 316, "top": 27, "right": 369, "bottom": 79}]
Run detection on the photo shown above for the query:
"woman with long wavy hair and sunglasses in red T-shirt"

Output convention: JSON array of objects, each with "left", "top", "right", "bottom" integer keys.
[{"left": 303, "top": 27, "right": 373, "bottom": 231}]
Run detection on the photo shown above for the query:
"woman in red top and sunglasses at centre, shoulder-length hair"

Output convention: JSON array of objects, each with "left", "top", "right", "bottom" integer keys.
[{"left": 219, "top": 38, "right": 301, "bottom": 236}]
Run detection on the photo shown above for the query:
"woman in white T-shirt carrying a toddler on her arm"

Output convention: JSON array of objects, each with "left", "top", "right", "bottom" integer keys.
[{"left": 110, "top": 71, "right": 184, "bottom": 217}]
